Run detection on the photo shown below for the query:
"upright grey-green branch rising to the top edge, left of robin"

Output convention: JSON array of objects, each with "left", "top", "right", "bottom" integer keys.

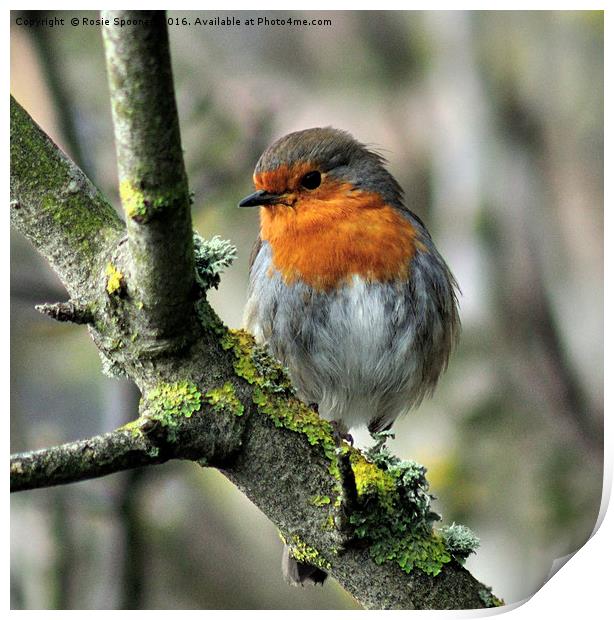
[{"left": 103, "top": 11, "right": 194, "bottom": 350}]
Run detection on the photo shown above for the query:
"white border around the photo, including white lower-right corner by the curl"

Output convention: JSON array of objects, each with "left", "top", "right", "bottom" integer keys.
[{"left": 6, "top": 0, "right": 614, "bottom": 620}]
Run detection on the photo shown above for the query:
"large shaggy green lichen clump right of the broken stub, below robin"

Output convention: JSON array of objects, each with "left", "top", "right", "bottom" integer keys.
[{"left": 350, "top": 439, "right": 452, "bottom": 576}]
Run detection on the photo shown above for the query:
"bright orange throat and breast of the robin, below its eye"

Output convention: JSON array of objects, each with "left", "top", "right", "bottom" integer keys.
[{"left": 260, "top": 184, "right": 416, "bottom": 290}]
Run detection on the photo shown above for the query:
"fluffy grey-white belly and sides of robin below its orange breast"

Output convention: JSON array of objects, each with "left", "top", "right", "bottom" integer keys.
[{"left": 244, "top": 240, "right": 459, "bottom": 431}]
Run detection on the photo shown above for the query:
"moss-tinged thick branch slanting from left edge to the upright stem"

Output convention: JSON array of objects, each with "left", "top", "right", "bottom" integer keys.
[{"left": 11, "top": 97, "right": 123, "bottom": 297}]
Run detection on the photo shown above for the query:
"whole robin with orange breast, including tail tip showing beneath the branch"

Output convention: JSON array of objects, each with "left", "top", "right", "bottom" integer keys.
[{"left": 239, "top": 127, "right": 460, "bottom": 585}]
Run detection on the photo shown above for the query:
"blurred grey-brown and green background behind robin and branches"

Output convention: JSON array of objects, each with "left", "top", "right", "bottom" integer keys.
[{"left": 11, "top": 11, "right": 603, "bottom": 609}]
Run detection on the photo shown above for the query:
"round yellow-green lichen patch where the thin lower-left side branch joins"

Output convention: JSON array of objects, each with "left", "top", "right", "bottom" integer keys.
[{"left": 143, "top": 381, "right": 201, "bottom": 441}]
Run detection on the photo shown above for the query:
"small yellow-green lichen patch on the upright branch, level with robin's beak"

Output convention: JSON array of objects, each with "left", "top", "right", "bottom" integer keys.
[{"left": 119, "top": 179, "right": 190, "bottom": 224}]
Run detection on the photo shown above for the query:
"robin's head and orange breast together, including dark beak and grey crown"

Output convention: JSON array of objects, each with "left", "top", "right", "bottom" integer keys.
[{"left": 239, "top": 127, "right": 417, "bottom": 290}]
